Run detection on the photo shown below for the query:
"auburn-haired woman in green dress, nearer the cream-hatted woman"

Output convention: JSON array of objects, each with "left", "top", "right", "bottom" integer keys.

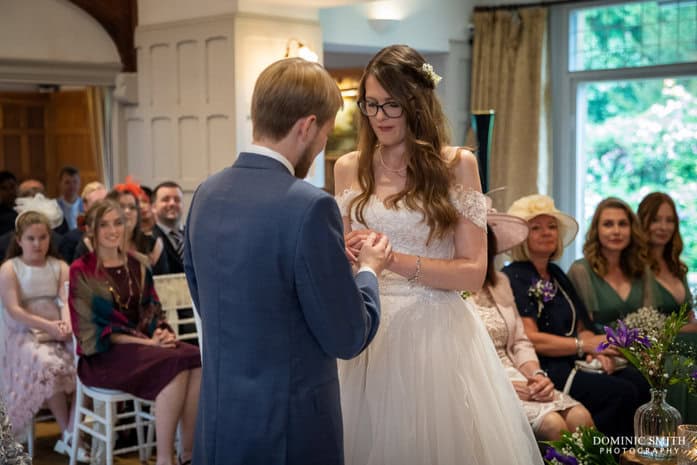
[{"left": 569, "top": 197, "right": 654, "bottom": 332}]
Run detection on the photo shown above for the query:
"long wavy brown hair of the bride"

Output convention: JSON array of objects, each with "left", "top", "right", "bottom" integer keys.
[{"left": 350, "top": 45, "right": 458, "bottom": 241}]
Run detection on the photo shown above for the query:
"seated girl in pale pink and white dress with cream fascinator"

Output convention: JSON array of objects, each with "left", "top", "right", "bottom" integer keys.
[{"left": 0, "top": 194, "right": 87, "bottom": 461}]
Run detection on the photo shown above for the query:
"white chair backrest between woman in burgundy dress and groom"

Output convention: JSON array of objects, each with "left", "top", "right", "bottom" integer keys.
[{"left": 153, "top": 273, "right": 199, "bottom": 341}]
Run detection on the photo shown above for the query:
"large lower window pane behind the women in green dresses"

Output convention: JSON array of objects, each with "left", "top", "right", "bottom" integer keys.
[{"left": 577, "top": 77, "right": 697, "bottom": 283}]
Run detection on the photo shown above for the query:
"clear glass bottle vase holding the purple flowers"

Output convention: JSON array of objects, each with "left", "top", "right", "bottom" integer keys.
[{"left": 634, "top": 389, "right": 682, "bottom": 460}]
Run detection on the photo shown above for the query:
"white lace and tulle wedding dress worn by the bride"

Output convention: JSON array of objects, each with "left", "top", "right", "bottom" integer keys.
[{"left": 337, "top": 188, "right": 542, "bottom": 465}]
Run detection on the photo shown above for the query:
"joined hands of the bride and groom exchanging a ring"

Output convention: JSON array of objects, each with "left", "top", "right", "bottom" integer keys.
[{"left": 344, "top": 229, "right": 394, "bottom": 275}]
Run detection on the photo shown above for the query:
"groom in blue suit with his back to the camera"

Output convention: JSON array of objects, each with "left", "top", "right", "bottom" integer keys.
[{"left": 184, "top": 58, "right": 391, "bottom": 465}]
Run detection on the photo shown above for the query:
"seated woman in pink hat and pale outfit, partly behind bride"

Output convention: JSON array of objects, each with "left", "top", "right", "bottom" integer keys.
[{"left": 473, "top": 204, "right": 593, "bottom": 441}]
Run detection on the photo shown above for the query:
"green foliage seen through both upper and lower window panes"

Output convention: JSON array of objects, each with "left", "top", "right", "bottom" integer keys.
[{"left": 570, "top": 0, "right": 697, "bottom": 280}]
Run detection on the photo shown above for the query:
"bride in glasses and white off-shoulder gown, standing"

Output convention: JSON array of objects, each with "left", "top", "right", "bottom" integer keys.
[{"left": 335, "top": 45, "right": 542, "bottom": 465}]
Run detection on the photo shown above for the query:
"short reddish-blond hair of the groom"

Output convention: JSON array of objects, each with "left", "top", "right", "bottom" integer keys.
[{"left": 252, "top": 58, "right": 343, "bottom": 142}]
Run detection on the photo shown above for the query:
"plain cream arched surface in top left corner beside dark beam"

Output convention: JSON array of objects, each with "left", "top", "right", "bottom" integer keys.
[{"left": 0, "top": 0, "right": 121, "bottom": 64}]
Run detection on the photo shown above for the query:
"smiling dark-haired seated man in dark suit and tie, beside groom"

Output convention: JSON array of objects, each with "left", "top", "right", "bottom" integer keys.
[{"left": 152, "top": 181, "right": 184, "bottom": 274}]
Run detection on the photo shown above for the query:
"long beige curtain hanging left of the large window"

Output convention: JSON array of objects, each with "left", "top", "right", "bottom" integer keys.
[{"left": 468, "top": 7, "right": 549, "bottom": 211}]
